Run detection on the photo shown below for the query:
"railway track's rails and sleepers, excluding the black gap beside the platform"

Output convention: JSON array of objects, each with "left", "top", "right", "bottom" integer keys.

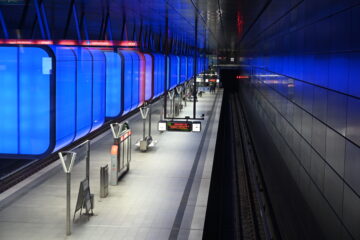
[{"left": 229, "top": 92, "right": 280, "bottom": 240}]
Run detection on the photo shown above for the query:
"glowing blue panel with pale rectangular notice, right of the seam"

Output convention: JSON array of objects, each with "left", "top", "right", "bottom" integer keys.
[{"left": 18, "top": 48, "right": 52, "bottom": 155}]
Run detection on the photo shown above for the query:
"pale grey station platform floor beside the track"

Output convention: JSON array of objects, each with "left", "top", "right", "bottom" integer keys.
[{"left": 0, "top": 90, "right": 223, "bottom": 240}]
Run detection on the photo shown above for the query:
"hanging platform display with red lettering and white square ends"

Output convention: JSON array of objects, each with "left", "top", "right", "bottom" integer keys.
[{"left": 158, "top": 121, "right": 201, "bottom": 132}]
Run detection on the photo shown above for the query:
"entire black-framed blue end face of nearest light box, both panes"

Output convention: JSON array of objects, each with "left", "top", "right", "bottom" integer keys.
[{"left": 0, "top": 47, "right": 52, "bottom": 155}]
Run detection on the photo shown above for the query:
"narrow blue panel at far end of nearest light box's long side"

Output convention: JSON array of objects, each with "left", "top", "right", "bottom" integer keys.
[{"left": 90, "top": 49, "right": 105, "bottom": 131}]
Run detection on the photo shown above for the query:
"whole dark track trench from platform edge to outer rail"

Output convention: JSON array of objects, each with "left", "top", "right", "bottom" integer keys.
[{"left": 203, "top": 87, "right": 280, "bottom": 240}]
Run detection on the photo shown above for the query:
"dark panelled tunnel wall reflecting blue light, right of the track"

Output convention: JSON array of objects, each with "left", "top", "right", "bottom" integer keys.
[{"left": 242, "top": 0, "right": 360, "bottom": 239}]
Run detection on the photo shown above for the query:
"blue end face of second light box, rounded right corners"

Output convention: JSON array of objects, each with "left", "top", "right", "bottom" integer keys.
[{"left": 105, "top": 51, "right": 122, "bottom": 117}]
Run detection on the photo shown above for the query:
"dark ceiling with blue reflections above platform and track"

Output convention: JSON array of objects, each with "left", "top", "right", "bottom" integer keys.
[{"left": 0, "top": 0, "right": 290, "bottom": 53}]
